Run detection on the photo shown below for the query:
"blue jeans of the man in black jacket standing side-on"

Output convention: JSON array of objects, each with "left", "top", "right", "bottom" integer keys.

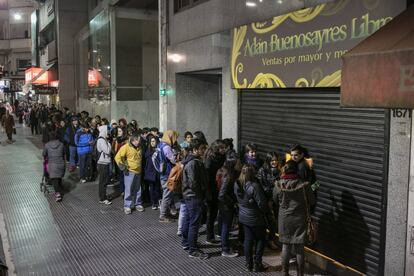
[{"left": 182, "top": 198, "right": 203, "bottom": 253}]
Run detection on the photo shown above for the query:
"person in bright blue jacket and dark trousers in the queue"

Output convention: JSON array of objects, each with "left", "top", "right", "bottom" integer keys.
[{"left": 75, "top": 123, "right": 93, "bottom": 183}]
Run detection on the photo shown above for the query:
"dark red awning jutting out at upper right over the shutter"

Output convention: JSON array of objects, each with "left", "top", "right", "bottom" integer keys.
[{"left": 341, "top": 5, "right": 414, "bottom": 108}]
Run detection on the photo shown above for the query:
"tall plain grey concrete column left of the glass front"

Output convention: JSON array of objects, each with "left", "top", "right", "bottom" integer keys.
[{"left": 55, "top": 0, "right": 88, "bottom": 110}]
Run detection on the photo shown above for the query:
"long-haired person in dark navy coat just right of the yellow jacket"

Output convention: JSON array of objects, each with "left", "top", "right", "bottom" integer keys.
[{"left": 141, "top": 134, "right": 160, "bottom": 210}]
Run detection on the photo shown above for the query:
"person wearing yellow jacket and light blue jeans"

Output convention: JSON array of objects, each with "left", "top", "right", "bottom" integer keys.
[{"left": 115, "top": 133, "right": 145, "bottom": 215}]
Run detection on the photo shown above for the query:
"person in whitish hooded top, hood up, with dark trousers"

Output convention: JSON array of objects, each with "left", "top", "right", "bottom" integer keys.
[{"left": 96, "top": 125, "right": 112, "bottom": 205}]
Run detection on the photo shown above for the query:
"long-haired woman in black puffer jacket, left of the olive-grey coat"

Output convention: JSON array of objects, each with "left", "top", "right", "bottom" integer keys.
[{"left": 234, "top": 165, "right": 269, "bottom": 272}]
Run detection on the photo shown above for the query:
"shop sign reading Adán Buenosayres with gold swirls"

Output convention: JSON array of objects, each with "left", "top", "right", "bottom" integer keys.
[{"left": 231, "top": 0, "right": 406, "bottom": 89}]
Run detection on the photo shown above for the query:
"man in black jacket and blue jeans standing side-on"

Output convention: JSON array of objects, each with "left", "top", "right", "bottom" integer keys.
[{"left": 182, "top": 139, "right": 209, "bottom": 260}]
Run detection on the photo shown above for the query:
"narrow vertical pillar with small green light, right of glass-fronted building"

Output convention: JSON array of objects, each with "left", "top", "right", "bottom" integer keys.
[{"left": 158, "top": 0, "right": 168, "bottom": 131}]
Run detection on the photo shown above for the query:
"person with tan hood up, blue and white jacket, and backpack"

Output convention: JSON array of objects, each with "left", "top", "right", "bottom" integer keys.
[{"left": 157, "top": 130, "right": 178, "bottom": 223}]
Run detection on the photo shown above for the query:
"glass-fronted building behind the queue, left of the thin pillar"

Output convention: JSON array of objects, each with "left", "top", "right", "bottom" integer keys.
[{"left": 26, "top": 0, "right": 159, "bottom": 126}]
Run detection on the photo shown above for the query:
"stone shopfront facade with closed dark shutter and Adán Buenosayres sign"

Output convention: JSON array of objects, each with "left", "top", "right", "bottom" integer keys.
[{"left": 160, "top": 0, "right": 413, "bottom": 275}]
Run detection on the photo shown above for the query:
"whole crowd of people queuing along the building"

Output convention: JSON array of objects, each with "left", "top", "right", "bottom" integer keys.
[{"left": 1, "top": 104, "right": 318, "bottom": 275}]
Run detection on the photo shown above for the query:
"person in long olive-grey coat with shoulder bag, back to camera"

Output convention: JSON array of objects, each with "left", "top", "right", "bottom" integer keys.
[{"left": 273, "top": 160, "right": 315, "bottom": 275}]
